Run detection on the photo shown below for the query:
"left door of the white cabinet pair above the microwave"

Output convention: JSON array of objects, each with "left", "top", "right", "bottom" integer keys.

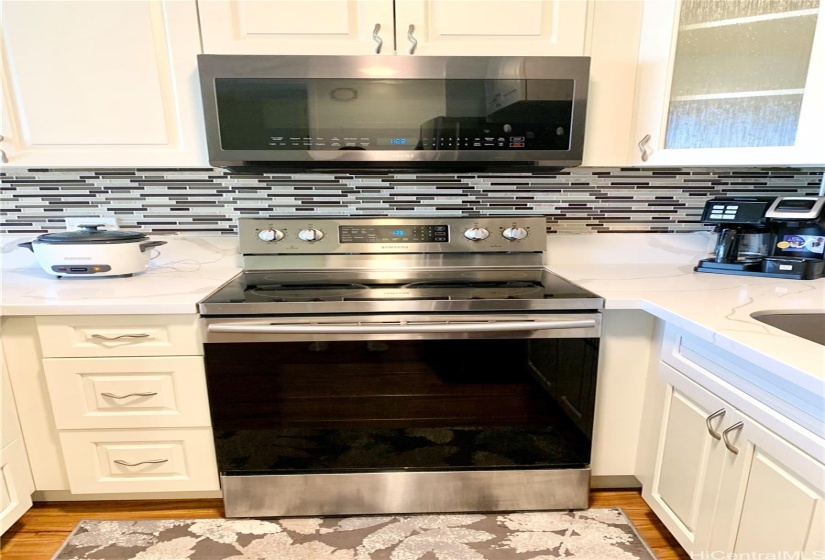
[{"left": 198, "top": 0, "right": 395, "bottom": 55}]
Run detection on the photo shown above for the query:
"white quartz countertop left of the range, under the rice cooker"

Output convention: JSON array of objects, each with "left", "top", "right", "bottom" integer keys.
[{"left": 0, "top": 235, "right": 241, "bottom": 315}]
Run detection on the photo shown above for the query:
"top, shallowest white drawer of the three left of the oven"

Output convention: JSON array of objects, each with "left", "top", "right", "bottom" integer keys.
[{"left": 36, "top": 315, "right": 203, "bottom": 358}]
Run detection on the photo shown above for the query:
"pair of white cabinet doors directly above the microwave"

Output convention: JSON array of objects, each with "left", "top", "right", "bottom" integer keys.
[{"left": 198, "top": 0, "right": 590, "bottom": 56}]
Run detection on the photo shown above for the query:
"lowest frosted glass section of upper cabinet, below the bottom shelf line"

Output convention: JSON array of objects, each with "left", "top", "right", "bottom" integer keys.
[{"left": 665, "top": 95, "right": 802, "bottom": 149}]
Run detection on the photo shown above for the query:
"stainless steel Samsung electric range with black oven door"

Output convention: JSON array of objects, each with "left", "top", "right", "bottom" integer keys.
[{"left": 200, "top": 217, "right": 603, "bottom": 517}]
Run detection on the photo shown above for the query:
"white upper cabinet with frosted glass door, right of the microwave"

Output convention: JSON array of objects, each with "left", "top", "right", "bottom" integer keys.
[{"left": 630, "top": 0, "right": 825, "bottom": 165}]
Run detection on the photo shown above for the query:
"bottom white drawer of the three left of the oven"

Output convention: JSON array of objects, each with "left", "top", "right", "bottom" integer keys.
[{"left": 60, "top": 428, "right": 219, "bottom": 494}]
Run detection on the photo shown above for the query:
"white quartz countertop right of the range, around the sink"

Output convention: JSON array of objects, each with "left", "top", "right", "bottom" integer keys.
[{"left": 548, "top": 234, "right": 825, "bottom": 400}]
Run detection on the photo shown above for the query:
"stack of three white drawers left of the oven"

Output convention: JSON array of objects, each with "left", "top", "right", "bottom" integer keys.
[{"left": 36, "top": 315, "right": 219, "bottom": 494}]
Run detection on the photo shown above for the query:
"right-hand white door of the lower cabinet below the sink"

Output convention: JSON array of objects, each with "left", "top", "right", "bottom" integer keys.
[{"left": 708, "top": 413, "right": 825, "bottom": 557}]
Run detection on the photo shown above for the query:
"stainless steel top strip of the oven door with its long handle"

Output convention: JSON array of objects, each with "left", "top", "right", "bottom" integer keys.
[{"left": 201, "top": 313, "right": 601, "bottom": 343}]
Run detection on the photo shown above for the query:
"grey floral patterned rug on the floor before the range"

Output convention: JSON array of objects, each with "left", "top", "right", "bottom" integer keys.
[{"left": 53, "top": 508, "right": 655, "bottom": 560}]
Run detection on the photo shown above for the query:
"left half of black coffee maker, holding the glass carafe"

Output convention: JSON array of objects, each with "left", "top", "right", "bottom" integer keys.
[{"left": 695, "top": 196, "right": 776, "bottom": 274}]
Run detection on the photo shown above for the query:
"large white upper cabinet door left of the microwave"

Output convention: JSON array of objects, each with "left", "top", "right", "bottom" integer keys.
[{"left": 0, "top": 0, "right": 206, "bottom": 167}]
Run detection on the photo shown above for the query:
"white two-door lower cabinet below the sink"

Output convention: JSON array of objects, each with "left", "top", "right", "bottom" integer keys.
[{"left": 642, "top": 363, "right": 825, "bottom": 555}]
